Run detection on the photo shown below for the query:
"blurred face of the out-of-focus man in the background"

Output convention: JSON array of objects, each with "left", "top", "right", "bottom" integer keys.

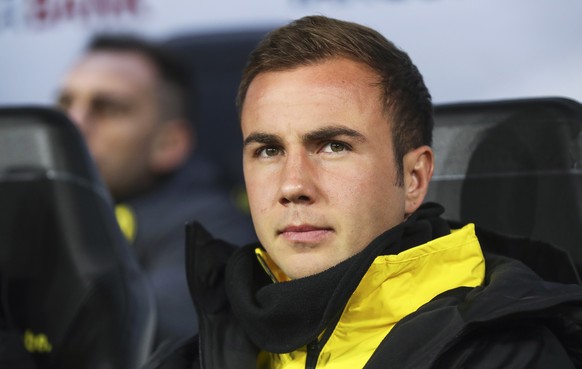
[{"left": 59, "top": 51, "right": 160, "bottom": 199}]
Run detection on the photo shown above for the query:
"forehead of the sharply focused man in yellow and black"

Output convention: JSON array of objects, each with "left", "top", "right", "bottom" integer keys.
[{"left": 241, "top": 58, "right": 385, "bottom": 133}]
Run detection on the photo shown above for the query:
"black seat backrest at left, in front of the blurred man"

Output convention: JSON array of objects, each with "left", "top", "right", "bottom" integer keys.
[{"left": 0, "top": 107, "right": 155, "bottom": 369}]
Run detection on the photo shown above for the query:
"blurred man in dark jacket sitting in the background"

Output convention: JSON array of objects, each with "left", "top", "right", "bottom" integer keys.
[{"left": 58, "top": 35, "right": 256, "bottom": 344}]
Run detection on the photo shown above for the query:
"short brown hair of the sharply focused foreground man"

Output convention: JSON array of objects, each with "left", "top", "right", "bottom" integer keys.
[{"left": 236, "top": 16, "right": 433, "bottom": 185}]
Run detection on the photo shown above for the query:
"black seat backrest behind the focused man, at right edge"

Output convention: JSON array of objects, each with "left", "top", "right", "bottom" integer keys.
[{"left": 426, "top": 98, "right": 582, "bottom": 271}]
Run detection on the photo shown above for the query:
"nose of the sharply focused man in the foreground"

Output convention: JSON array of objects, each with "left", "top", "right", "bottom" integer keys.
[{"left": 279, "top": 153, "right": 317, "bottom": 206}]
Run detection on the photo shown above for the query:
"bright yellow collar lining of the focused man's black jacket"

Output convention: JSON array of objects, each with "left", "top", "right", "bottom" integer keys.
[{"left": 266, "top": 225, "right": 485, "bottom": 368}]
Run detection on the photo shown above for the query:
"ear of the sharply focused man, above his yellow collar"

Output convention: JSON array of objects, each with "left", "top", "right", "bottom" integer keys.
[{"left": 403, "top": 146, "right": 434, "bottom": 216}]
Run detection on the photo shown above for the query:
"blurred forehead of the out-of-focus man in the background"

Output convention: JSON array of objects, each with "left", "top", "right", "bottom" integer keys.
[{"left": 63, "top": 51, "right": 157, "bottom": 92}]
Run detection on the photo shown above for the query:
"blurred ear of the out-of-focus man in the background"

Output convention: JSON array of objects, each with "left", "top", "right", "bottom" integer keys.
[{"left": 150, "top": 120, "right": 195, "bottom": 175}]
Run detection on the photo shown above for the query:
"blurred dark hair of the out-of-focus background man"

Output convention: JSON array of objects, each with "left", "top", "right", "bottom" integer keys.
[{"left": 86, "top": 34, "right": 192, "bottom": 119}]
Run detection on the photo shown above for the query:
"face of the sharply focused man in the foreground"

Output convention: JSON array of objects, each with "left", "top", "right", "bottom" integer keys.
[{"left": 241, "top": 59, "right": 405, "bottom": 278}]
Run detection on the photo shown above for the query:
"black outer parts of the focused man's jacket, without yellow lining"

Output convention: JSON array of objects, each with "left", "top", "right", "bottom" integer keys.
[{"left": 146, "top": 214, "right": 582, "bottom": 369}]
